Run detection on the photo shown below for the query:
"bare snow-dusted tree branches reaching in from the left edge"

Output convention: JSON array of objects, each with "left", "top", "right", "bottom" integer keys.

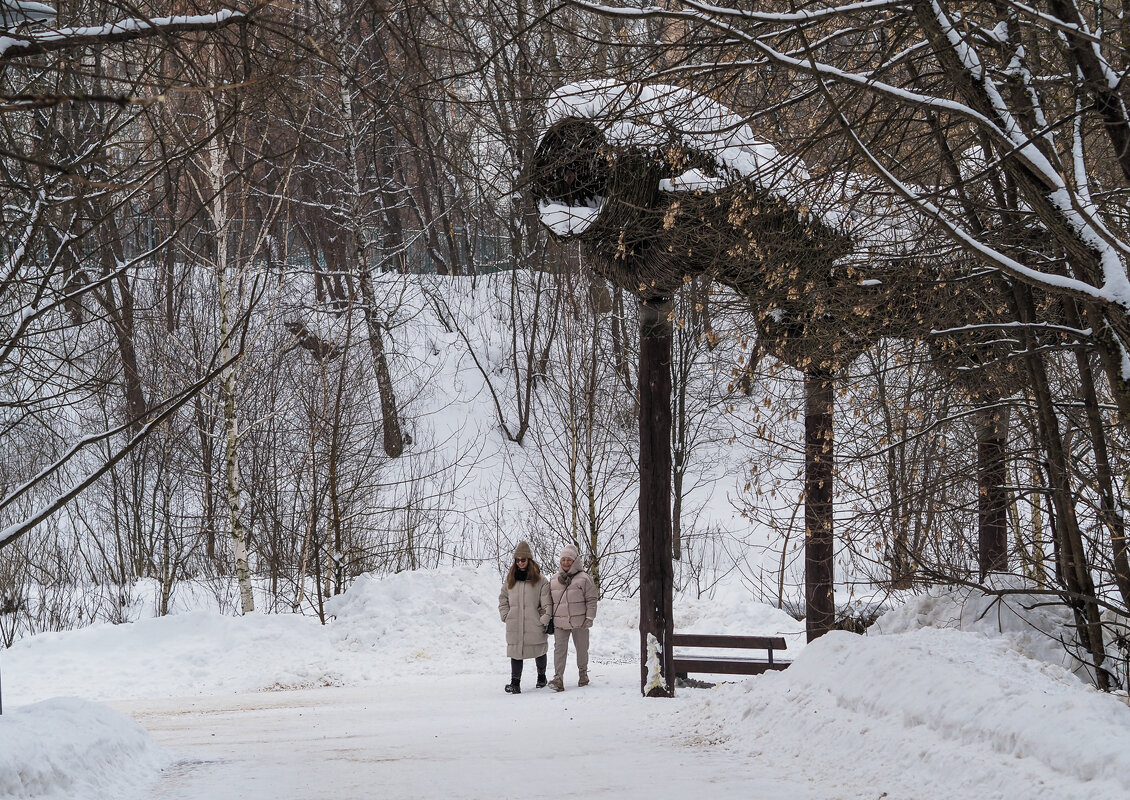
[{"left": 0, "top": 3, "right": 251, "bottom": 555}]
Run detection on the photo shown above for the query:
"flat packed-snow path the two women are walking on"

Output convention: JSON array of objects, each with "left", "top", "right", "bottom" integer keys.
[{"left": 113, "top": 663, "right": 813, "bottom": 800}]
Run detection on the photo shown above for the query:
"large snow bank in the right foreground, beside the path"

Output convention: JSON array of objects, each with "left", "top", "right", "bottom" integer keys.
[{"left": 679, "top": 628, "right": 1130, "bottom": 800}]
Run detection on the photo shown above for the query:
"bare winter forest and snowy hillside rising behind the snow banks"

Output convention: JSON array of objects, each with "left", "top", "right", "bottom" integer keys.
[{"left": 0, "top": 0, "right": 1130, "bottom": 714}]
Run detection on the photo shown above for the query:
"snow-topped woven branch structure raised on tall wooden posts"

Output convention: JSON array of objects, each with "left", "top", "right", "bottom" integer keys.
[{"left": 532, "top": 81, "right": 1039, "bottom": 391}]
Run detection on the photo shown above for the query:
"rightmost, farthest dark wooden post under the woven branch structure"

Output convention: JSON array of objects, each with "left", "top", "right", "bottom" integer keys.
[{"left": 977, "top": 406, "right": 1008, "bottom": 579}]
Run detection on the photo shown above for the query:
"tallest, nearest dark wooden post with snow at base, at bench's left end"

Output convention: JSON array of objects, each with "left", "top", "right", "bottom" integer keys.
[{"left": 640, "top": 297, "right": 675, "bottom": 697}]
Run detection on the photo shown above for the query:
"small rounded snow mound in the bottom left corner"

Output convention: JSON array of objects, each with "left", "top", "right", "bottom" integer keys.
[{"left": 0, "top": 697, "right": 167, "bottom": 800}]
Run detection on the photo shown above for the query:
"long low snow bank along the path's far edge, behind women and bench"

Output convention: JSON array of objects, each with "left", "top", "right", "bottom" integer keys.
[{"left": 3, "top": 566, "right": 803, "bottom": 703}]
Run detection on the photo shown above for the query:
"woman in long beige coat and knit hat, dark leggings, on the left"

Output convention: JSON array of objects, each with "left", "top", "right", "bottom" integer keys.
[{"left": 498, "top": 541, "right": 549, "bottom": 695}]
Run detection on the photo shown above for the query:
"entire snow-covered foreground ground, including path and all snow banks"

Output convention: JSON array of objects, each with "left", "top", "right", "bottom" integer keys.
[{"left": 0, "top": 567, "right": 1130, "bottom": 800}]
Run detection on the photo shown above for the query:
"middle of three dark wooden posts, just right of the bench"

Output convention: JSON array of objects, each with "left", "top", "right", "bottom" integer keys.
[{"left": 805, "top": 371, "right": 836, "bottom": 642}]
